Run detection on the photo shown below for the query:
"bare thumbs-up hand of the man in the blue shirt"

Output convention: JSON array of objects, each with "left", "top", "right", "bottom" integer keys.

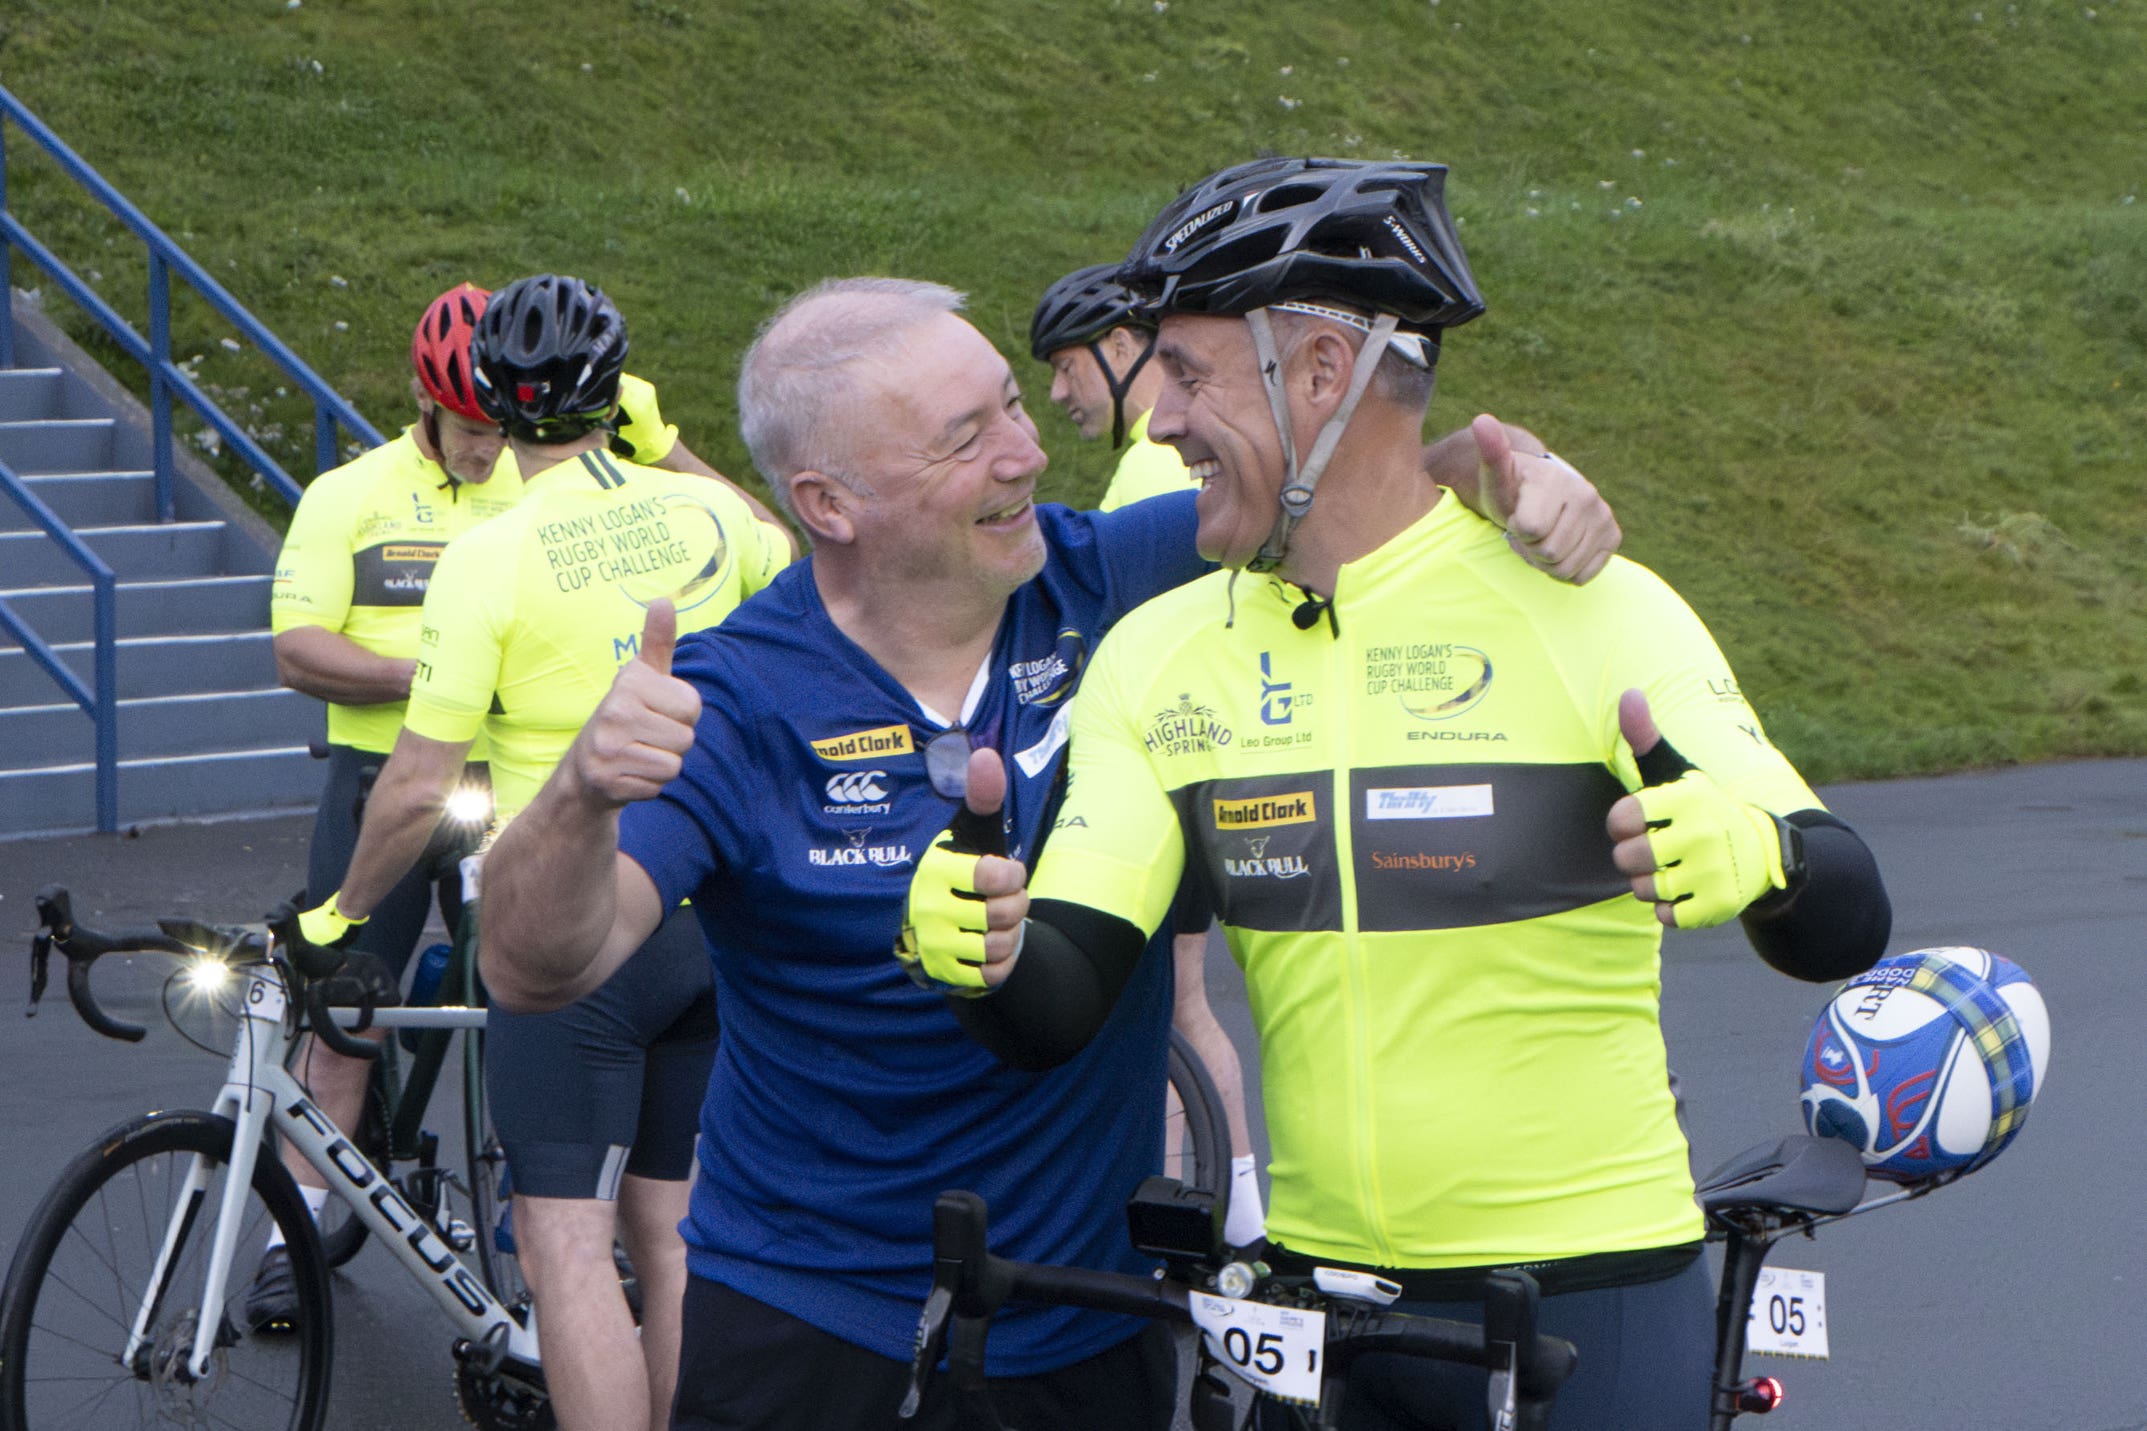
[{"left": 560, "top": 601, "right": 700, "bottom": 809}]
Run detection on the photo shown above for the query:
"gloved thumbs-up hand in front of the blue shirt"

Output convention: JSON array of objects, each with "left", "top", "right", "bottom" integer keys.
[{"left": 895, "top": 749, "right": 1028, "bottom": 998}]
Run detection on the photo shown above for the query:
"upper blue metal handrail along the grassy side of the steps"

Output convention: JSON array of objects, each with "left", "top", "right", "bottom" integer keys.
[{"left": 0, "top": 88, "right": 382, "bottom": 521}]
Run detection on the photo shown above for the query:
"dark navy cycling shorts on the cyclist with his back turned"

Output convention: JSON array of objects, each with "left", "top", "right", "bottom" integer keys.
[{"left": 479, "top": 905, "right": 717, "bottom": 1201}]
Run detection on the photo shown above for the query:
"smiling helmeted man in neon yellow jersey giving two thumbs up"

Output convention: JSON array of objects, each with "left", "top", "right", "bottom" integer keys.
[{"left": 904, "top": 161, "right": 1889, "bottom": 1431}]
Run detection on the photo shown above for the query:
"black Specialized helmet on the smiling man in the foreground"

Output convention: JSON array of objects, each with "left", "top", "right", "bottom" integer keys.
[{"left": 1119, "top": 159, "right": 1484, "bottom": 333}]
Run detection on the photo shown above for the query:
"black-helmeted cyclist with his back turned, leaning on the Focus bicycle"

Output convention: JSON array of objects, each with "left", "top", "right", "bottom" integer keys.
[{"left": 301, "top": 275, "right": 792, "bottom": 1431}]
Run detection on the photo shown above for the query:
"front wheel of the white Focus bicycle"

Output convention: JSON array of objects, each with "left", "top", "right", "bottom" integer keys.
[{"left": 0, "top": 1113, "right": 333, "bottom": 1431}]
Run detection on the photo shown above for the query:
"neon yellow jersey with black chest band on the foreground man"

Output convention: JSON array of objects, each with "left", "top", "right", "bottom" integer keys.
[{"left": 1033, "top": 500, "right": 1819, "bottom": 1268}]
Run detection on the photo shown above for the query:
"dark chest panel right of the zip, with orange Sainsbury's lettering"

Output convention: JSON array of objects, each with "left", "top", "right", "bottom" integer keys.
[{"left": 1348, "top": 764, "right": 1632, "bottom": 933}]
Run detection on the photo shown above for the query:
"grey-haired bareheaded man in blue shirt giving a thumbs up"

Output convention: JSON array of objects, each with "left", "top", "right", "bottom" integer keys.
[{"left": 483, "top": 279, "right": 1615, "bottom": 1429}]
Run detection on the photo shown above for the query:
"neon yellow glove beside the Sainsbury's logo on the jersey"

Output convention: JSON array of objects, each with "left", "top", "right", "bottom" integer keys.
[{"left": 1634, "top": 770, "right": 1788, "bottom": 929}]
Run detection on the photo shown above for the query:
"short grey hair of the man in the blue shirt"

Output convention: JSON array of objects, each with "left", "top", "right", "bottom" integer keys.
[{"left": 739, "top": 279, "right": 966, "bottom": 521}]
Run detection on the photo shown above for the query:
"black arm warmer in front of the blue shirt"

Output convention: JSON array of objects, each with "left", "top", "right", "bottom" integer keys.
[{"left": 947, "top": 899, "right": 1149, "bottom": 1071}]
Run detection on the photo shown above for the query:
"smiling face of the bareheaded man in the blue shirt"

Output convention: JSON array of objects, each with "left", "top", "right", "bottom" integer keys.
[{"left": 855, "top": 313, "right": 1046, "bottom": 592}]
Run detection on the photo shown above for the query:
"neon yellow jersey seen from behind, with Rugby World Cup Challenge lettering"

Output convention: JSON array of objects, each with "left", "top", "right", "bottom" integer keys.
[{"left": 406, "top": 453, "right": 790, "bottom": 824}]
